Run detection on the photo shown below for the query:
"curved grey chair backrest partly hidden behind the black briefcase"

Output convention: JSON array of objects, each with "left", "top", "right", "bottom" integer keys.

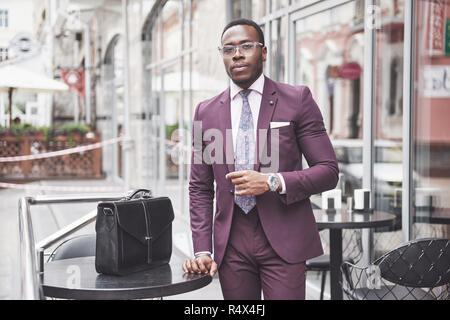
[{"left": 51, "top": 234, "right": 96, "bottom": 260}]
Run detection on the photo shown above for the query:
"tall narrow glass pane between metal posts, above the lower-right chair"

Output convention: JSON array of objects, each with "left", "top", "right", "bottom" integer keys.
[{"left": 373, "top": 0, "right": 404, "bottom": 259}]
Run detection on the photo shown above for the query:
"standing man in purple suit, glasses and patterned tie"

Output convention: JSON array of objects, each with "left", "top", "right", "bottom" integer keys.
[{"left": 183, "top": 19, "right": 338, "bottom": 300}]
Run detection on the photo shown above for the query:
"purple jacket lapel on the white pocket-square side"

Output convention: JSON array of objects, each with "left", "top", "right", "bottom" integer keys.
[{"left": 254, "top": 77, "right": 278, "bottom": 171}]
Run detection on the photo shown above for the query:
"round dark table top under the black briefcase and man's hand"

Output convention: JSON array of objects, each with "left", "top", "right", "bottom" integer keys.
[{"left": 42, "top": 256, "right": 212, "bottom": 300}]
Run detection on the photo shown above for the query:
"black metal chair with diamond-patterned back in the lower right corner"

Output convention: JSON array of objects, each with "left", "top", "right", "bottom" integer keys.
[{"left": 341, "top": 238, "right": 450, "bottom": 300}]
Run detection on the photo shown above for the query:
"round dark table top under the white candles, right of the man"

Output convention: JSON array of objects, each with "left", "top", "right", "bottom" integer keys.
[{"left": 313, "top": 209, "right": 396, "bottom": 229}]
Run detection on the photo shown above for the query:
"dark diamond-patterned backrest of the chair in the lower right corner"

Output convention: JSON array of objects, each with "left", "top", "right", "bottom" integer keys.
[{"left": 374, "top": 239, "right": 450, "bottom": 288}]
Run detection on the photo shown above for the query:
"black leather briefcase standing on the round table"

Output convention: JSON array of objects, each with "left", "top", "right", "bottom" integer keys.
[{"left": 95, "top": 189, "right": 174, "bottom": 275}]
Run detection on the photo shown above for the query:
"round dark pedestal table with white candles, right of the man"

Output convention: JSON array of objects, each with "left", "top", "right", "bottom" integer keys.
[{"left": 313, "top": 209, "right": 396, "bottom": 300}]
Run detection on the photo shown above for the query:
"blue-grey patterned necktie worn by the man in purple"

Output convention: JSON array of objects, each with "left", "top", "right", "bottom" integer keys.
[{"left": 234, "top": 89, "right": 256, "bottom": 213}]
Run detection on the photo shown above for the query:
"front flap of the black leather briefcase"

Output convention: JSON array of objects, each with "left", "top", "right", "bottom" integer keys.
[{"left": 115, "top": 197, "right": 174, "bottom": 245}]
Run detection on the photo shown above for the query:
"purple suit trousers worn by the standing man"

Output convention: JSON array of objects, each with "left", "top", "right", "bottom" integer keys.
[{"left": 218, "top": 204, "right": 306, "bottom": 300}]
